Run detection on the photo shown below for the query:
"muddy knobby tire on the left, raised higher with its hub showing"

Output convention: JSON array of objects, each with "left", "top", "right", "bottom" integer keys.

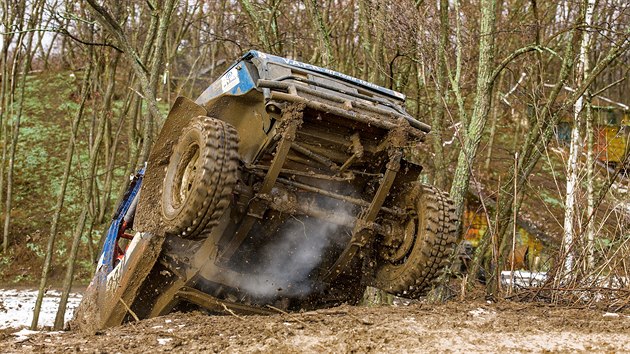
[{"left": 161, "top": 116, "right": 239, "bottom": 238}]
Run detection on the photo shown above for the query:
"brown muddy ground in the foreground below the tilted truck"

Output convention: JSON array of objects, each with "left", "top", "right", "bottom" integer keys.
[{"left": 0, "top": 302, "right": 630, "bottom": 353}]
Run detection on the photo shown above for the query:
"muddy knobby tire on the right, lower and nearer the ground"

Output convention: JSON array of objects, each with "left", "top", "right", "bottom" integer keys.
[{"left": 374, "top": 183, "right": 457, "bottom": 298}]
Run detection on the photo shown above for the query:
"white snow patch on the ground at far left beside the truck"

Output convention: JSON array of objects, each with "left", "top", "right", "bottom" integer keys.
[{"left": 0, "top": 289, "right": 81, "bottom": 329}]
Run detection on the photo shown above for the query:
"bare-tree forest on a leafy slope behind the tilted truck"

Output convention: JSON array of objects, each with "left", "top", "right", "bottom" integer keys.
[{"left": 0, "top": 0, "right": 630, "bottom": 310}]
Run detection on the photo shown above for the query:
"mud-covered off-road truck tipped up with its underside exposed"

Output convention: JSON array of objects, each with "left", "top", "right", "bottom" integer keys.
[{"left": 72, "top": 51, "right": 456, "bottom": 330}]
